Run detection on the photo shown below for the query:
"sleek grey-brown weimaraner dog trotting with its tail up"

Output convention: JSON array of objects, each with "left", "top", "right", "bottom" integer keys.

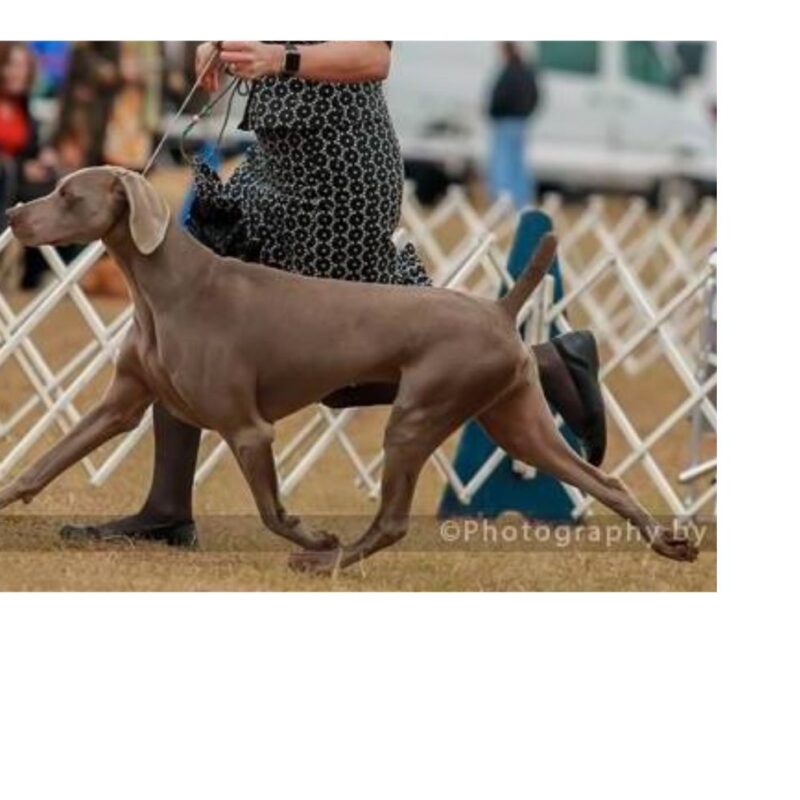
[{"left": 0, "top": 167, "right": 697, "bottom": 574}]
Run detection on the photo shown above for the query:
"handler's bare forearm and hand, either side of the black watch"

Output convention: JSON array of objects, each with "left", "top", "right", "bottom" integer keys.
[{"left": 221, "top": 42, "right": 391, "bottom": 83}]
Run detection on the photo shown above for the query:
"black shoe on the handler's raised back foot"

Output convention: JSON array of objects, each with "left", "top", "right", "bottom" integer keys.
[{"left": 552, "top": 331, "right": 606, "bottom": 467}]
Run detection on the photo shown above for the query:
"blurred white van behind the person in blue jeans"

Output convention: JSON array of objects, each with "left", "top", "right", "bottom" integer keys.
[{"left": 385, "top": 41, "right": 716, "bottom": 205}]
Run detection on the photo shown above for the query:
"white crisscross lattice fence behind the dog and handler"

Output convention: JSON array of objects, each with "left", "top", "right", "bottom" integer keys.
[{"left": 0, "top": 188, "right": 716, "bottom": 514}]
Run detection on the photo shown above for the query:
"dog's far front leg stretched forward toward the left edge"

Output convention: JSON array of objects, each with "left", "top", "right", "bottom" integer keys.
[{"left": 0, "top": 374, "right": 153, "bottom": 509}]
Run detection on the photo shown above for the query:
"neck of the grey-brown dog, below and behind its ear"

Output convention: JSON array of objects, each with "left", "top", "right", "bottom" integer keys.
[{"left": 103, "top": 215, "right": 210, "bottom": 313}]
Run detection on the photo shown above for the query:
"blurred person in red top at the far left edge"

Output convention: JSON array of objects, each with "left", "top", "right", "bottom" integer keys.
[{"left": 0, "top": 42, "right": 58, "bottom": 289}]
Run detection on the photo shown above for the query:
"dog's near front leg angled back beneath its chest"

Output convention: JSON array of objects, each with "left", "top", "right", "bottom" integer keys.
[{"left": 225, "top": 423, "right": 339, "bottom": 550}]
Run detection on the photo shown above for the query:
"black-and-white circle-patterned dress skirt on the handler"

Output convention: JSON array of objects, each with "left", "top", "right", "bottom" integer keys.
[{"left": 187, "top": 44, "right": 430, "bottom": 285}]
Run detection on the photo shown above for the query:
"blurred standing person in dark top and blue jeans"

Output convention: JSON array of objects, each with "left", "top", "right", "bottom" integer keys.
[{"left": 488, "top": 42, "right": 539, "bottom": 209}]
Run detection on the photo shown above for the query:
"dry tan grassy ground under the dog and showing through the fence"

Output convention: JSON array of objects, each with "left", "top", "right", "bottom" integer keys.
[{"left": 0, "top": 169, "right": 716, "bottom": 591}]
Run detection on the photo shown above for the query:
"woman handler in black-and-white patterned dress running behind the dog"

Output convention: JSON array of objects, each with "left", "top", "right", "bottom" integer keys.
[{"left": 62, "top": 42, "right": 605, "bottom": 545}]
